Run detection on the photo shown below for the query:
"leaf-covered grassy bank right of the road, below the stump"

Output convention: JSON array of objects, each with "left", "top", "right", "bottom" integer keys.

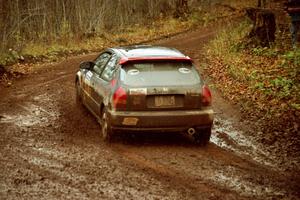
[{"left": 205, "top": 20, "right": 300, "bottom": 141}]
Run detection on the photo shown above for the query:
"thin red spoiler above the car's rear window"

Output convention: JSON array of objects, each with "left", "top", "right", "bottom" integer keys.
[{"left": 119, "top": 56, "right": 193, "bottom": 65}]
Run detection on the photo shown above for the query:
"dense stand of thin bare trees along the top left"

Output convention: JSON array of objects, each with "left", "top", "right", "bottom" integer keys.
[{"left": 0, "top": 0, "right": 210, "bottom": 52}]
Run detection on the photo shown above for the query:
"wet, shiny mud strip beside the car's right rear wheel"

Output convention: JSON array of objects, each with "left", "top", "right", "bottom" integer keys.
[{"left": 210, "top": 117, "right": 279, "bottom": 170}]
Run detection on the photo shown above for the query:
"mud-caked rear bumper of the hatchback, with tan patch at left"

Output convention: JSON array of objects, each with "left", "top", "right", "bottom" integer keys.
[{"left": 108, "top": 108, "right": 214, "bottom": 132}]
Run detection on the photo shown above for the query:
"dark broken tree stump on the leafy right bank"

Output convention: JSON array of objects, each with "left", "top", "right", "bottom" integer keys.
[{"left": 246, "top": 8, "right": 276, "bottom": 47}]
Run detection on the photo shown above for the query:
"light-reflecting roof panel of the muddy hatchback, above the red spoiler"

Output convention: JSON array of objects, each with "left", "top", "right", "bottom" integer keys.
[{"left": 114, "top": 45, "right": 185, "bottom": 58}]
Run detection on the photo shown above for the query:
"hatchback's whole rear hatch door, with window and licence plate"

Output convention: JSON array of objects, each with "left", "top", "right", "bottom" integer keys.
[{"left": 121, "top": 61, "right": 202, "bottom": 111}]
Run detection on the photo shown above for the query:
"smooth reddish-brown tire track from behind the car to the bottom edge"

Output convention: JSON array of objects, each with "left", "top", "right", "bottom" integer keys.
[{"left": 111, "top": 145, "right": 248, "bottom": 199}]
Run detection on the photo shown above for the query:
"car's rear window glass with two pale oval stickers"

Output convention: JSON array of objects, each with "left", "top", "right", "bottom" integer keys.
[{"left": 121, "top": 61, "right": 200, "bottom": 87}]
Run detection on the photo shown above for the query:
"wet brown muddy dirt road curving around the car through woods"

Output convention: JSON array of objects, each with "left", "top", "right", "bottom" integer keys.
[{"left": 0, "top": 29, "right": 300, "bottom": 200}]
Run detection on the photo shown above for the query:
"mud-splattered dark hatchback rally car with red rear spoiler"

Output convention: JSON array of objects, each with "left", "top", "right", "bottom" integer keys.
[{"left": 75, "top": 45, "right": 213, "bottom": 144}]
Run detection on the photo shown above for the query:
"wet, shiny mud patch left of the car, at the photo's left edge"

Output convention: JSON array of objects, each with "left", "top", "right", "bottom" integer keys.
[{"left": 0, "top": 94, "right": 58, "bottom": 127}]
